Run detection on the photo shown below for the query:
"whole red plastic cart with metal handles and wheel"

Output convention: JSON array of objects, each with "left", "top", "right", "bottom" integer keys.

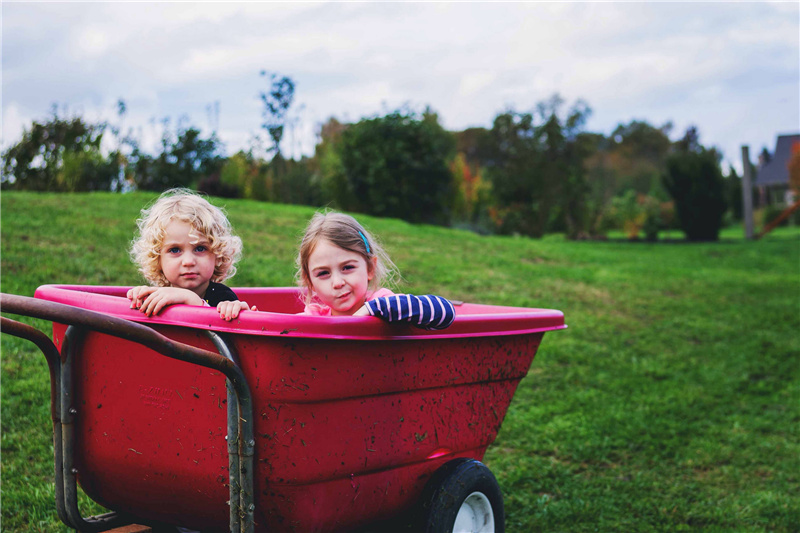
[{"left": 2, "top": 285, "right": 566, "bottom": 532}]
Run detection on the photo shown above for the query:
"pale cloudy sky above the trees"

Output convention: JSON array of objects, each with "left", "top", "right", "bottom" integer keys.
[{"left": 0, "top": 0, "right": 800, "bottom": 175}]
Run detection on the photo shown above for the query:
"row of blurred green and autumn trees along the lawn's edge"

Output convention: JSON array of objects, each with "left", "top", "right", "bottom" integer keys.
[{"left": 0, "top": 78, "right": 741, "bottom": 240}]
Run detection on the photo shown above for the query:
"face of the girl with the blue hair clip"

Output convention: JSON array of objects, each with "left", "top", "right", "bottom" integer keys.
[{"left": 308, "top": 240, "right": 374, "bottom": 316}]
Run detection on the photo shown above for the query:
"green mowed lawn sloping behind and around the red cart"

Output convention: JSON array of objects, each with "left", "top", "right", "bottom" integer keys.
[{"left": 1, "top": 192, "right": 800, "bottom": 533}]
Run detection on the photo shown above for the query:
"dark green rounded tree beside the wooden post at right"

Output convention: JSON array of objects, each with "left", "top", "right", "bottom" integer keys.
[{"left": 663, "top": 127, "right": 726, "bottom": 241}]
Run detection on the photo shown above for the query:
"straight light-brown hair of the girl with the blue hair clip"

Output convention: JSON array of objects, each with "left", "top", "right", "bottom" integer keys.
[{"left": 296, "top": 211, "right": 400, "bottom": 304}]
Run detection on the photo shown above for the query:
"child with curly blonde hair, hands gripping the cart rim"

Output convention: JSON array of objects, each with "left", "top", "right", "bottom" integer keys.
[{"left": 127, "top": 189, "right": 250, "bottom": 320}]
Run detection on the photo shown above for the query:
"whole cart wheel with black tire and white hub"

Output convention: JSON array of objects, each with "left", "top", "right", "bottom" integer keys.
[{"left": 418, "top": 458, "right": 505, "bottom": 533}]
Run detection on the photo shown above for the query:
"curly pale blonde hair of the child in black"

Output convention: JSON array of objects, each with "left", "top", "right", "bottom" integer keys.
[{"left": 130, "top": 189, "right": 242, "bottom": 287}]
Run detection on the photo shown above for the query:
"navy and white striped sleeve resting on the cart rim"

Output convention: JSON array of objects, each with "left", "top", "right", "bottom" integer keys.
[{"left": 366, "top": 294, "right": 456, "bottom": 329}]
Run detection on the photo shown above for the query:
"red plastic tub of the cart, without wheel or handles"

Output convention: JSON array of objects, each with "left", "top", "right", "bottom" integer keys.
[{"left": 28, "top": 286, "right": 565, "bottom": 532}]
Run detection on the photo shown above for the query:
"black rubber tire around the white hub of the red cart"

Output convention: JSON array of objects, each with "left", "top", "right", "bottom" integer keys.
[{"left": 416, "top": 458, "right": 505, "bottom": 533}]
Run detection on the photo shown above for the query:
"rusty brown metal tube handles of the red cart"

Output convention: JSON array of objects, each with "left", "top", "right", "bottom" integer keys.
[{"left": 0, "top": 293, "right": 255, "bottom": 533}]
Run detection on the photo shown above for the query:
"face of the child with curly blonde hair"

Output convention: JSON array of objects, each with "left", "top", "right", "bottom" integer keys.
[{"left": 161, "top": 220, "right": 217, "bottom": 298}]
